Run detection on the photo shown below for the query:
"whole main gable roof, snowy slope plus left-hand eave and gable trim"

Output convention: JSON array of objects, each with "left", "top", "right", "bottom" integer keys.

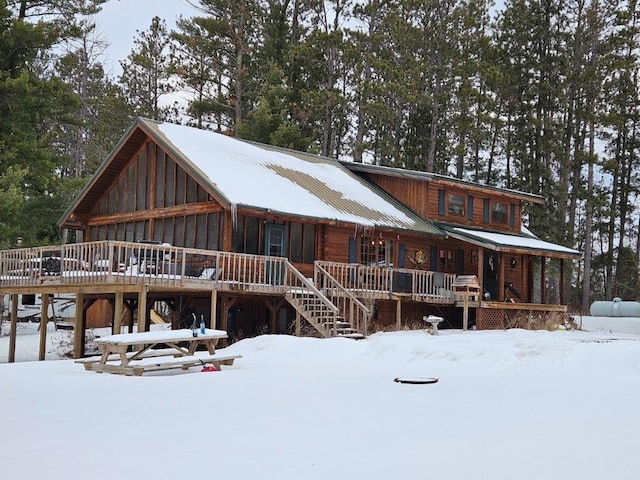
[{"left": 59, "top": 119, "right": 444, "bottom": 236}]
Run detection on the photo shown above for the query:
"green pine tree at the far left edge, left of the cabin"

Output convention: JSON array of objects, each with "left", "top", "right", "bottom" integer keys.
[{"left": 0, "top": 0, "right": 102, "bottom": 245}]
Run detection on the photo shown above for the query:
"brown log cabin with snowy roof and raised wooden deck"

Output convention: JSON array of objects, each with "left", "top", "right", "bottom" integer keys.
[{"left": 0, "top": 119, "right": 579, "bottom": 358}]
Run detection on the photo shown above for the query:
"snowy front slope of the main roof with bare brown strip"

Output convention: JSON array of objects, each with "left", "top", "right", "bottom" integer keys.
[{"left": 148, "top": 122, "right": 439, "bottom": 234}]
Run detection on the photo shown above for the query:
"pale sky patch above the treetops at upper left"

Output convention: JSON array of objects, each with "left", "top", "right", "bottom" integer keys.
[{"left": 95, "top": 0, "right": 198, "bottom": 76}]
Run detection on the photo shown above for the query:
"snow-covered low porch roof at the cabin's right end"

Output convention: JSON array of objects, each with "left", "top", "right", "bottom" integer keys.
[{"left": 441, "top": 226, "right": 581, "bottom": 258}]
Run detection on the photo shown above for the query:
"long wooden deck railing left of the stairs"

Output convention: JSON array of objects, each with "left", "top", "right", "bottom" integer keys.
[{"left": 0, "top": 240, "right": 338, "bottom": 301}]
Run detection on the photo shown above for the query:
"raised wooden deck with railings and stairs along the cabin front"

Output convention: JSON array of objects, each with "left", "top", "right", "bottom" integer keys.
[{"left": 0, "top": 241, "right": 566, "bottom": 342}]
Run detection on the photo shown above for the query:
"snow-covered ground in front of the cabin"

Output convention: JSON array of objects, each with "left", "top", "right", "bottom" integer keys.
[{"left": 0, "top": 317, "right": 640, "bottom": 480}]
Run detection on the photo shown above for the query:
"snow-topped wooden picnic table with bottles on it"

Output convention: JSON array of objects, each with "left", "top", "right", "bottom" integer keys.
[{"left": 76, "top": 329, "right": 241, "bottom": 375}]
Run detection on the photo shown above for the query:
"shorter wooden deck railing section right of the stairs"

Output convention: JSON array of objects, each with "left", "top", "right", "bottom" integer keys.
[{"left": 316, "top": 261, "right": 456, "bottom": 303}]
